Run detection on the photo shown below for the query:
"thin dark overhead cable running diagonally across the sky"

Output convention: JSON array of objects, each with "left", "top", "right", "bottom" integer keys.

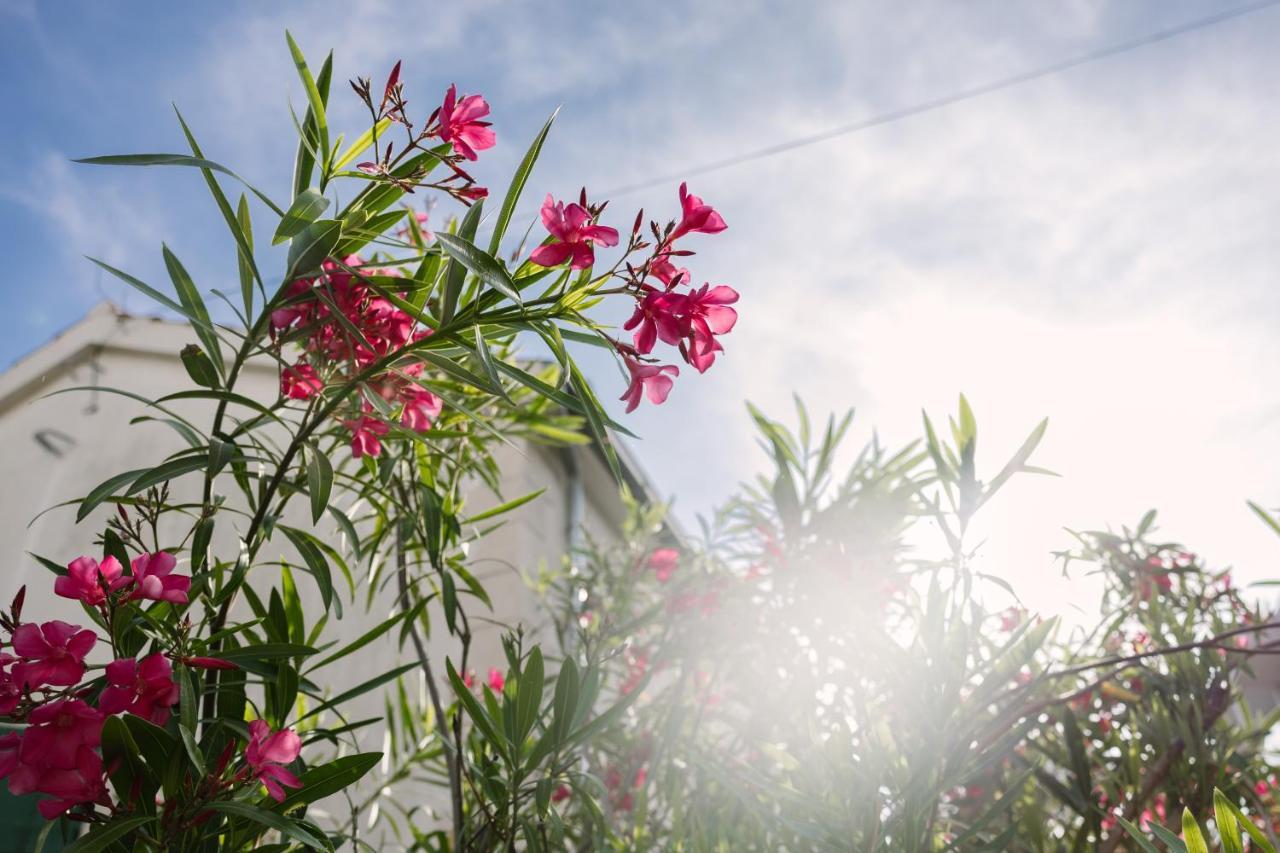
[{"left": 599, "top": 0, "right": 1280, "bottom": 199}]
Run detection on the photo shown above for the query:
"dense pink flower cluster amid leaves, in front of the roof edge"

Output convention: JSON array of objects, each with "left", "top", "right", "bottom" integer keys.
[{"left": 271, "top": 255, "right": 443, "bottom": 459}]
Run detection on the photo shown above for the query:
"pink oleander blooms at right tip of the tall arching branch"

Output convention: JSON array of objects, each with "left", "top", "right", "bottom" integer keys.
[{"left": 530, "top": 183, "right": 739, "bottom": 412}]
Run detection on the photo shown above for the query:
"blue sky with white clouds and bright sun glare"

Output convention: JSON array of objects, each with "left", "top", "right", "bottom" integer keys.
[{"left": 0, "top": 0, "right": 1280, "bottom": 610}]
